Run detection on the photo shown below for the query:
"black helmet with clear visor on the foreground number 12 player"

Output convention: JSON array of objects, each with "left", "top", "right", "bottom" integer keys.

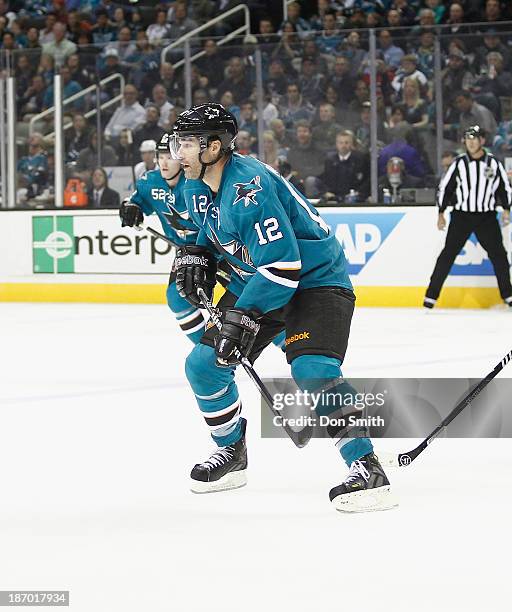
[{"left": 170, "top": 102, "right": 238, "bottom": 178}]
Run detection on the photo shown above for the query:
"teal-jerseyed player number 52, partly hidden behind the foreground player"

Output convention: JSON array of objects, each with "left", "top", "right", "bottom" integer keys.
[{"left": 119, "top": 134, "right": 205, "bottom": 344}]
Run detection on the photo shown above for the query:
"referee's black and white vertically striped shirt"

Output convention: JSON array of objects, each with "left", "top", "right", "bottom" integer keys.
[{"left": 437, "top": 152, "right": 512, "bottom": 212}]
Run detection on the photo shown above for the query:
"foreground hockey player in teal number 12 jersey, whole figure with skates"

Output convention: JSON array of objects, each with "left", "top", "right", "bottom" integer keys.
[{"left": 171, "top": 103, "right": 396, "bottom": 512}]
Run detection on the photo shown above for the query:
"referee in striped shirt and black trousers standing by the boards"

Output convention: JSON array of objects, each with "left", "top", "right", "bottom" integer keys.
[{"left": 423, "top": 125, "right": 512, "bottom": 308}]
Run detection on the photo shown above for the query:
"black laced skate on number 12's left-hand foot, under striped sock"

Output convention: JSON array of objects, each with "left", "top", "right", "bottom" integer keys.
[{"left": 190, "top": 419, "right": 247, "bottom": 493}]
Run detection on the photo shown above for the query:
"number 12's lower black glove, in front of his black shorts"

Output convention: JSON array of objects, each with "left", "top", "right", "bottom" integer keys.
[{"left": 215, "top": 308, "right": 260, "bottom": 366}]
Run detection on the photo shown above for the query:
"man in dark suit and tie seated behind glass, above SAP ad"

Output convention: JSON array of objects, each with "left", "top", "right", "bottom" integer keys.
[{"left": 318, "top": 130, "right": 370, "bottom": 202}]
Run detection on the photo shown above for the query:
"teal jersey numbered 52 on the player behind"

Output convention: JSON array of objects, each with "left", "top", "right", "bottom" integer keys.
[{"left": 130, "top": 169, "right": 200, "bottom": 244}]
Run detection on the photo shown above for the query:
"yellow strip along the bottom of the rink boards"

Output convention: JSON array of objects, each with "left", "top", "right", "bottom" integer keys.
[{"left": 0, "top": 283, "right": 502, "bottom": 308}]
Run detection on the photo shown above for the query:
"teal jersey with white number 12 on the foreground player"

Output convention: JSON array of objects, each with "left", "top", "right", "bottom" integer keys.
[{"left": 183, "top": 153, "right": 352, "bottom": 313}]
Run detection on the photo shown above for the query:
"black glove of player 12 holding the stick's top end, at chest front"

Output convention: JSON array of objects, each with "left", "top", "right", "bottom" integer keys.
[{"left": 174, "top": 245, "right": 217, "bottom": 307}]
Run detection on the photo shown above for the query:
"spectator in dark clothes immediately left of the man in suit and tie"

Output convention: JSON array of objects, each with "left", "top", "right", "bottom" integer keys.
[{"left": 288, "top": 120, "right": 324, "bottom": 196}]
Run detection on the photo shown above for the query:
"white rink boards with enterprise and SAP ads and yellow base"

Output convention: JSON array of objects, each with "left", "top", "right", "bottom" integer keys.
[{"left": 0, "top": 207, "right": 512, "bottom": 308}]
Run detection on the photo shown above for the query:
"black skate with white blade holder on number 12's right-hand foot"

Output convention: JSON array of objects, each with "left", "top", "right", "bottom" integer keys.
[{"left": 329, "top": 453, "right": 398, "bottom": 512}]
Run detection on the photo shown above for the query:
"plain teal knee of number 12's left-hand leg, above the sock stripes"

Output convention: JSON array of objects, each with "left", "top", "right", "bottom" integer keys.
[{"left": 185, "top": 344, "right": 234, "bottom": 395}]
